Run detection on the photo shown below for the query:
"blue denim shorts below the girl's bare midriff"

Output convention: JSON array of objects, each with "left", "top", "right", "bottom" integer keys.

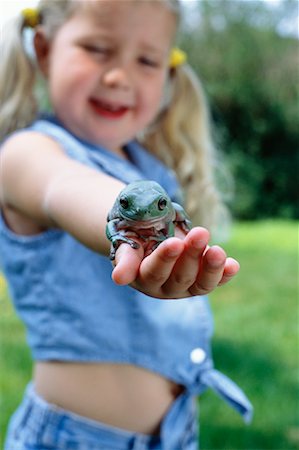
[{"left": 5, "top": 384, "right": 199, "bottom": 450}]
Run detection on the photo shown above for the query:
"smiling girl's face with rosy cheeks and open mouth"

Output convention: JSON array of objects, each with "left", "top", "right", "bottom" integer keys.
[{"left": 37, "top": 0, "right": 176, "bottom": 152}]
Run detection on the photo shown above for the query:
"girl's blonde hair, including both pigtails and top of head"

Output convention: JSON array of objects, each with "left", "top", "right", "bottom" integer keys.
[{"left": 0, "top": 0, "right": 228, "bottom": 237}]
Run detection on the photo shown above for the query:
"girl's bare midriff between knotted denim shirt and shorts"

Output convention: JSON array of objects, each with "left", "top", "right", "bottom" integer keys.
[{"left": 34, "top": 361, "right": 183, "bottom": 434}]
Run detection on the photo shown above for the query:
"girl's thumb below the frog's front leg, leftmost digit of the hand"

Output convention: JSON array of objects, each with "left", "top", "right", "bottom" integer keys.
[{"left": 112, "top": 243, "right": 144, "bottom": 285}]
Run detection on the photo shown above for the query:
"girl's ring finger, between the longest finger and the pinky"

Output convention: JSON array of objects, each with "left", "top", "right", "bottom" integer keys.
[{"left": 189, "top": 245, "right": 226, "bottom": 295}]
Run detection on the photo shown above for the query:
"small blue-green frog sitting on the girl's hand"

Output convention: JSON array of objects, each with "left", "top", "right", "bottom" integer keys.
[{"left": 106, "top": 180, "right": 192, "bottom": 261}]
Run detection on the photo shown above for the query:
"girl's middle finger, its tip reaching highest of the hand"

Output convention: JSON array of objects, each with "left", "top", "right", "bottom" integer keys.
[{"left": 164, "top": 227, "right": 210, "bottom": 292}]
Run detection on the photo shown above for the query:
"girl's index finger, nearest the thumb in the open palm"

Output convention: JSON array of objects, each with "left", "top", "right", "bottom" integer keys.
[{"left": 139, "top": 238, "right": 184, "bottom": 288}]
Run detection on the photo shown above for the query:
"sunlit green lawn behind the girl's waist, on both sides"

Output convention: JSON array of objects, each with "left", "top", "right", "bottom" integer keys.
[{"left": 0, "top": 221, "right": 299, "bottom": 450}]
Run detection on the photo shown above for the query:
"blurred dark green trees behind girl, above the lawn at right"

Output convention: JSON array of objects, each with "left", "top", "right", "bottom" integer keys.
[{"left": 181, "top": 0, "right": 299, "bottom": 219}]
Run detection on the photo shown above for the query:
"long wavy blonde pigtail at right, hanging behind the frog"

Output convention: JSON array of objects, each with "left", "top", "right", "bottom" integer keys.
[{"left": 143, "top": 64, "right": 229, "bottom": 239}]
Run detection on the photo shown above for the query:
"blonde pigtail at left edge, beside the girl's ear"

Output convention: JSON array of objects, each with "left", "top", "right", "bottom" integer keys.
[{"left": 0, "top": 14, "right": 37, "bottom": 141}]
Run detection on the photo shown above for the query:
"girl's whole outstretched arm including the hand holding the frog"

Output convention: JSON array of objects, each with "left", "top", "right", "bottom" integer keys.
[{"left": 0, "top": 132, "right": 239, "bottom": 298}]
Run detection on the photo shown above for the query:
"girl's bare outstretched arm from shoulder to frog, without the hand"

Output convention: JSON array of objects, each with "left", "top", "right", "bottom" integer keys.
[{"left": 0, "top": 132, "right": 124, "bottom": 254}]
